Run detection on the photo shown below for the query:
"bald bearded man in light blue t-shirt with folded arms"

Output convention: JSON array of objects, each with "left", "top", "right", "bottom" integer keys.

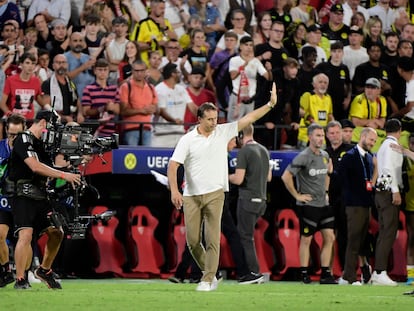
[{"left": 64, "top": 32, "right": 96, "bottom": 99}]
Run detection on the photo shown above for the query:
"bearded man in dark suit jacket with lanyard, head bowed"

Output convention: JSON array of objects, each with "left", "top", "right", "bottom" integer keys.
[{"left": 338, "top": 127, "right": 377, "bottom": 285}]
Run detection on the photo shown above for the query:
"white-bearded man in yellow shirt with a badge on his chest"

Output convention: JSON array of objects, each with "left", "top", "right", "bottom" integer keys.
[{"left": 298, "top": 73, "right": 333, "bottom": 150}]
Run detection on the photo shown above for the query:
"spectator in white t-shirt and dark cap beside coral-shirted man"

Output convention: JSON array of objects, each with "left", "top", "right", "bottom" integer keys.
[{"left": 151, "top": 63, "right": 198, "bottom": 148}]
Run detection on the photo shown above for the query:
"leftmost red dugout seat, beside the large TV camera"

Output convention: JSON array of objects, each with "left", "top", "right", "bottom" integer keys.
[{"left": 91, "top": 206, "right": 126, "bottom": 275}]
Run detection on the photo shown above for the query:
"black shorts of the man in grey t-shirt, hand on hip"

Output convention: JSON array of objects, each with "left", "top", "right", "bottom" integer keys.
[{"left": 298, "top": 205, "right": 335, "bottom": 236}]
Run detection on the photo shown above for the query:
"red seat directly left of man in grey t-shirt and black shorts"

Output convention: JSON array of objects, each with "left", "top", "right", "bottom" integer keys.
[{"left": 276, "top": 209, "right": 300, "bottom": 275}]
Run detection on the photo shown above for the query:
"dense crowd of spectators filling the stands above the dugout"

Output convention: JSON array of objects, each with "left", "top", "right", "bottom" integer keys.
[{"left": 0, "top": 0, "right": 414, "bottom": 285}]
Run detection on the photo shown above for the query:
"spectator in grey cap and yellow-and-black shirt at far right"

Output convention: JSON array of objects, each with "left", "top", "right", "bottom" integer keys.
[{"left": 349, "top": 78, "right": 387, "bottom": 129}]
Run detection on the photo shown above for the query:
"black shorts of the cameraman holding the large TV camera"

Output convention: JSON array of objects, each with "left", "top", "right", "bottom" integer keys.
[{"left": 12, "top": 196, "right": 51, "bottom": 234}]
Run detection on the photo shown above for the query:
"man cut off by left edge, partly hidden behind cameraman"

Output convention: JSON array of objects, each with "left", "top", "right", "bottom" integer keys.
[{"left": 0, "top": 114, "right": 26, "bottom": 287}]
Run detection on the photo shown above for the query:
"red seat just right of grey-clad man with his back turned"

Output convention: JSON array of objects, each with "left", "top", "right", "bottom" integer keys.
[{"left": 254, "top": 217, "right": 275, "bottom": 274}]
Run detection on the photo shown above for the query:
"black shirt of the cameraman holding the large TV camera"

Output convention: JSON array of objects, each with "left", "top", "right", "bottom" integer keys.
[{"left": 9, "top": 131, "right": 52, "bottom": 185}]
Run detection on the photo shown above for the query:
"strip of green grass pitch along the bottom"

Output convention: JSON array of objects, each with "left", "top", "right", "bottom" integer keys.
[{"left": 0, "top": 279, "right": 414, "bottom": 311}]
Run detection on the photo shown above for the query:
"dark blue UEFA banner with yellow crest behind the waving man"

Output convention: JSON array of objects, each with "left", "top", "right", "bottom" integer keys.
[{"left": 112, "top": 147, "right": 298, "bottom": 177}]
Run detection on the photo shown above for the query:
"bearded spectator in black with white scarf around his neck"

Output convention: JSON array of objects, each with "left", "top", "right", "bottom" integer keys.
[{"left": 42, "top": 54, "right": 83, "bottom": 122}]
